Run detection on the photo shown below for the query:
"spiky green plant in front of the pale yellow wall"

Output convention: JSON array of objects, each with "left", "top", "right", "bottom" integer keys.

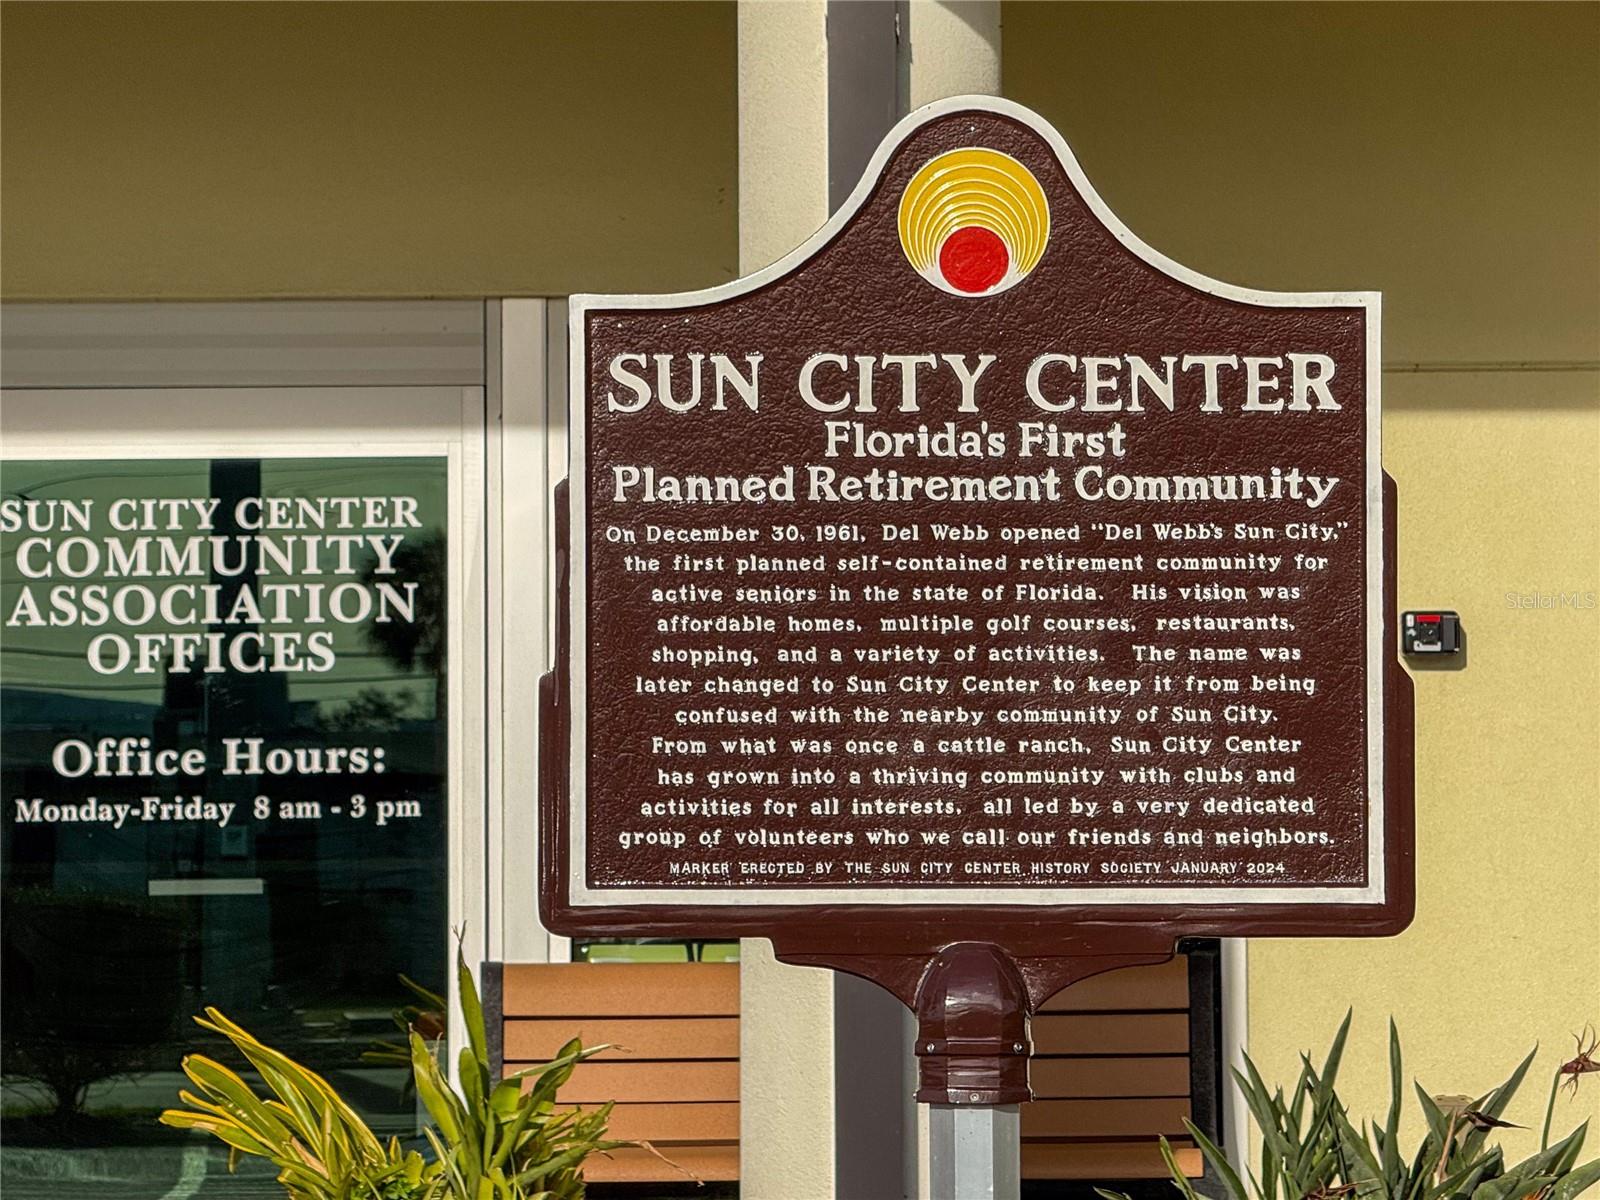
[{"left": 1096, "top": 1013, "right": 1600, "bottom": 1200}]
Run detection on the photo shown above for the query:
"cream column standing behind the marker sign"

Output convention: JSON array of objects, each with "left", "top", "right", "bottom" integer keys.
[{"left": 739, "top": 0, "right": 1000, "bottom": 1200}]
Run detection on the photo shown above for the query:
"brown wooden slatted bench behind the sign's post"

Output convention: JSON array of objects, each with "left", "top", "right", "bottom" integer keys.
[{"left": 483, "top": 957, "right": 1216, "bottom": 1182}]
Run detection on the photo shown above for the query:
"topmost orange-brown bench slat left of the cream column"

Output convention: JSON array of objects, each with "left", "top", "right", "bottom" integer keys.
[{"left": 501, "top": 963, "right": 739, "bottom": 1021}]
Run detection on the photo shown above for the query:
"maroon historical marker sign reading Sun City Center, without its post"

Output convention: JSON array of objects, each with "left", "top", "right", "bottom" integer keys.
[{"left": 544, "top": 99, "right": 1411, "bottom": 953}]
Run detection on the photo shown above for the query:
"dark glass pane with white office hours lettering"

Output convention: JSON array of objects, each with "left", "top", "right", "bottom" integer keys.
[{"left": 0, "top": 458, "right": 450, "bottom": 1200}]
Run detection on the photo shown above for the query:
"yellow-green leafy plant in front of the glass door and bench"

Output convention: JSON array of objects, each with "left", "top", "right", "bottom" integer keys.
[{"left": 162, "top": 950, "right": 632, "bottom": 1200}]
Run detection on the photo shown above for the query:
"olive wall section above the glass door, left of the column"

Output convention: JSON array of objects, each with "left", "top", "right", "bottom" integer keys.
[{"left": 0, "top": 3, "right": 738, "bottom": 299}]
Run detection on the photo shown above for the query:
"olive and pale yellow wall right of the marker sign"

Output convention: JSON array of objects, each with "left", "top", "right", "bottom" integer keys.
[{"left": 1002, "top": 3, "right": 1600, "bottom": 1149}]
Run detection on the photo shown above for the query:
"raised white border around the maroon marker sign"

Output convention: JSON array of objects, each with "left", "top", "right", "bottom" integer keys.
[{"left": 566, "top": 96, "right": 1387, "bottom": 907}]
